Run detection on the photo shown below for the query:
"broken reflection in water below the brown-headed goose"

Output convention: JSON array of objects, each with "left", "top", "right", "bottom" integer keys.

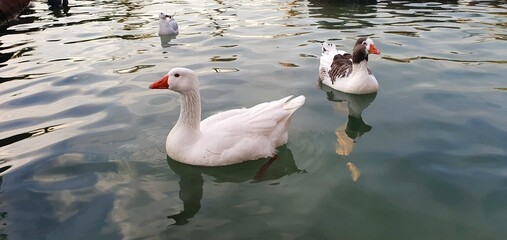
[{"left": 319, "top": 84, "right": 377, "bottom": 181}]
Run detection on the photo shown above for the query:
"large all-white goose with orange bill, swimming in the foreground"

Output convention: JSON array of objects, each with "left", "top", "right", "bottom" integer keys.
[{"left": 150, "top": 68, "right": 305, "bottom": 166}]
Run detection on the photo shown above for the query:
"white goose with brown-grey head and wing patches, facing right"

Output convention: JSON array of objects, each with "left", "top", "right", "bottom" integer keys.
[{"left": 319, "top": 37, "right": 380, "bottom": 94}]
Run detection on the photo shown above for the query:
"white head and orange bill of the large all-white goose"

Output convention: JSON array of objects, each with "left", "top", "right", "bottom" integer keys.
[{"left": 150, "top": 68, "right": 199, "bottom": 93}]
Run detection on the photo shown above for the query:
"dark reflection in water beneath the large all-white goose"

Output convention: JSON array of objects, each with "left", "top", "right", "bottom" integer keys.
[{"left": 167, "top": 145, "right": 305, "bottom": 226}]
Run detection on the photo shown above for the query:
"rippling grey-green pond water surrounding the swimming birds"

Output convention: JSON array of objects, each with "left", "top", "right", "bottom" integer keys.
[{"left": 0, "top": 0, "right": 507, "bottom": 240}]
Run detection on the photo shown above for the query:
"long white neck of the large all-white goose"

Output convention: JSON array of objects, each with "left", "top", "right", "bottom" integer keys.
[{"left": 176, "top": 90, "right": 201, "bottom": 131}]
